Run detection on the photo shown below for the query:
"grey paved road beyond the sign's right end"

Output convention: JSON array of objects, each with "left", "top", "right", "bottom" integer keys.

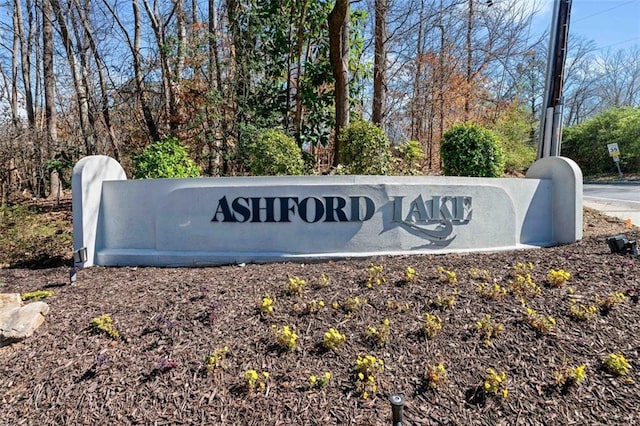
[{"left": 582, "top": 182, "right": 640, "bottom": 225}]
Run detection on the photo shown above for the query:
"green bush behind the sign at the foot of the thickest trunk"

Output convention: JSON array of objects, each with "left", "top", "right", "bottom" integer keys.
[{"left": 340, "top": 120, "right": 394, "bottom": 175}]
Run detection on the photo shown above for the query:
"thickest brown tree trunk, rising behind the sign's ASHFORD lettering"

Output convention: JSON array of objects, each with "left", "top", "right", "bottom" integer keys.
[{"left": 328, "top": 0, "right": 349, "bottom": 166}]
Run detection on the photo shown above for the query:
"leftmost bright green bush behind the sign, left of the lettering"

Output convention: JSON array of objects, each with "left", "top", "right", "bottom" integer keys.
[{"left": 134, "top": 136, "right": 200, "bottom": 179}]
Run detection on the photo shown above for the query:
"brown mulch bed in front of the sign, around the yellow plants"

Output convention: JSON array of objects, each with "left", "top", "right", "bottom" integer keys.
[{"left": 0, "top": 210, "right": 640, "bottom": 425}]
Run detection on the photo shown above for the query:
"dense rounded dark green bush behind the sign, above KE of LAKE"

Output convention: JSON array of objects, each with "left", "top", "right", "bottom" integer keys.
[{"left": 440, "top": 123, "right": 504, "bottom": 177}]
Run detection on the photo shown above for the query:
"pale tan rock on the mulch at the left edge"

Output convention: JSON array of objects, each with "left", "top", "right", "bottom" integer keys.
[{"left": 0, "top": 293, "right": 49, "bottom": 343}]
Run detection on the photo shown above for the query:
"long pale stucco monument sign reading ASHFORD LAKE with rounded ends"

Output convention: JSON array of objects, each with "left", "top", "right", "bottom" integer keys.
[{"left": 73, "top": 156, "right": 582, "bottom": 266}]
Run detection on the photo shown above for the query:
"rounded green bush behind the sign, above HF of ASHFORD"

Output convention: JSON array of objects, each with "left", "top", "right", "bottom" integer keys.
[{"left": 242, "top": 130, "right": 305, "bottom": 176}]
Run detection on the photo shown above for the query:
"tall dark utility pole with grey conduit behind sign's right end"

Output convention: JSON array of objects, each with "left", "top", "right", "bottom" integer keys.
[{"left": 538, "top": 0, "right": 571, "bottom": 158}]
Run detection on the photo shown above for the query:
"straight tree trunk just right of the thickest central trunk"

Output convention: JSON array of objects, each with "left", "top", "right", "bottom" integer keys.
[{"left": 371, "top": 0, "right": 389, "bottom": 126}]
